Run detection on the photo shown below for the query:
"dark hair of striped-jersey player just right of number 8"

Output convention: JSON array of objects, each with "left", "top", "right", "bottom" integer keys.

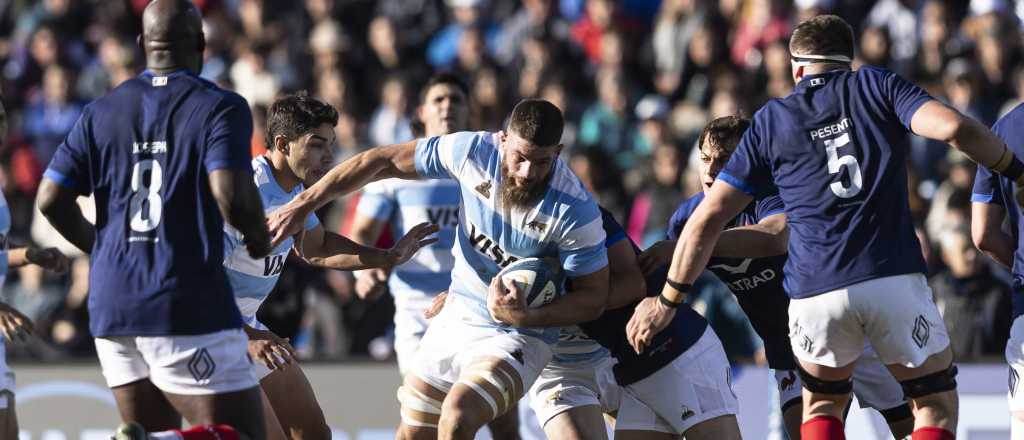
[{"left": 266, "top": 92, "right": 338, "bottom": 149}]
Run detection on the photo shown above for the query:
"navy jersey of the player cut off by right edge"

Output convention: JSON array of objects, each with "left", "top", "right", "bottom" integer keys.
[{"left": 971, "top": 105, "right": 1024, "bottom": 319}]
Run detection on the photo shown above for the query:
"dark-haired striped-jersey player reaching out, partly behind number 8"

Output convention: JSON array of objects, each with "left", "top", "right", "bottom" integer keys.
[{"left": 224, "top": 95, "right": 437, "bottom": 439}]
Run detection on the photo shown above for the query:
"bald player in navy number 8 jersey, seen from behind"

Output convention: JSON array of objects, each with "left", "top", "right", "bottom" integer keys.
[{"left": 38, "top": 0, "right": 270, "bottom": 440}]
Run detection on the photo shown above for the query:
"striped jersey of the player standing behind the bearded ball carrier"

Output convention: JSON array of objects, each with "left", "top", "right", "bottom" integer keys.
[{"left": 356, "top": 179, "right": 459, "bottom": 303}]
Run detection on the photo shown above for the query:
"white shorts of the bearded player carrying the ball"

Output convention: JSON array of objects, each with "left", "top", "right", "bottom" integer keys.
[{"left": 410, "top": 297, "right": 551, "bottom": 399}]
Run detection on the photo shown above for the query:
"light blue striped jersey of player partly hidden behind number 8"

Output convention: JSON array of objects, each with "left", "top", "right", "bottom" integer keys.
[{"left": 224, "top": 156, "right": 319, "bottom": 326}]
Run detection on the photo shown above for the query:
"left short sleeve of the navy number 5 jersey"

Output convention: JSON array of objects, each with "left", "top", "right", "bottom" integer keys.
[{"left": 717, "top": 118, "right": 774, "bottom": 197}]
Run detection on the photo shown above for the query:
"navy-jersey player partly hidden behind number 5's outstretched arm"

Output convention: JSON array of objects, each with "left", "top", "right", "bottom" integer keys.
[{"left": 639, "top": 117, "right": 913, "bottom": 440}]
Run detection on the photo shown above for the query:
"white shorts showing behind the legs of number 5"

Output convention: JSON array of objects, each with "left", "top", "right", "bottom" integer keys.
[{"left": 774, "top": 345, "right": 906, "bottom": 412}]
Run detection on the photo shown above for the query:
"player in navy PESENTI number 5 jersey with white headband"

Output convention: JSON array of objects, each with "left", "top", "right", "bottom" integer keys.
[{"left": 628, "top": 15, "right": 1024, "bottom": 440}]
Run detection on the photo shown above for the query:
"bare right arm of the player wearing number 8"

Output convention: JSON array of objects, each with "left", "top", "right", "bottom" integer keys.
[{"left": 210, "top": 168, "right": 271, "bottom": 258}]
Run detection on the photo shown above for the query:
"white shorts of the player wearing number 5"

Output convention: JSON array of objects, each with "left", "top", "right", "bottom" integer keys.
[{"left": 790, "top": 273, "right": 949, "bottom": 368}]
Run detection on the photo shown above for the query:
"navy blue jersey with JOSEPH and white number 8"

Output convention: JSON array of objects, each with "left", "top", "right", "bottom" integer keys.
[{"left": 46, "top": 71, "right": 252, "bottom": 337}]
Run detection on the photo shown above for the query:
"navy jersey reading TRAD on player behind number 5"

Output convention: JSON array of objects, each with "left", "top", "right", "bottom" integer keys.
[{"left": 668, "top": 192, "right": 797, "bottom": 369}]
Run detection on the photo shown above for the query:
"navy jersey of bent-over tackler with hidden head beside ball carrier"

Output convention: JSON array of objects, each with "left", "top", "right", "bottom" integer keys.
[{"left": 580, "top": 208, "right": 708, "bottom": 387}]
